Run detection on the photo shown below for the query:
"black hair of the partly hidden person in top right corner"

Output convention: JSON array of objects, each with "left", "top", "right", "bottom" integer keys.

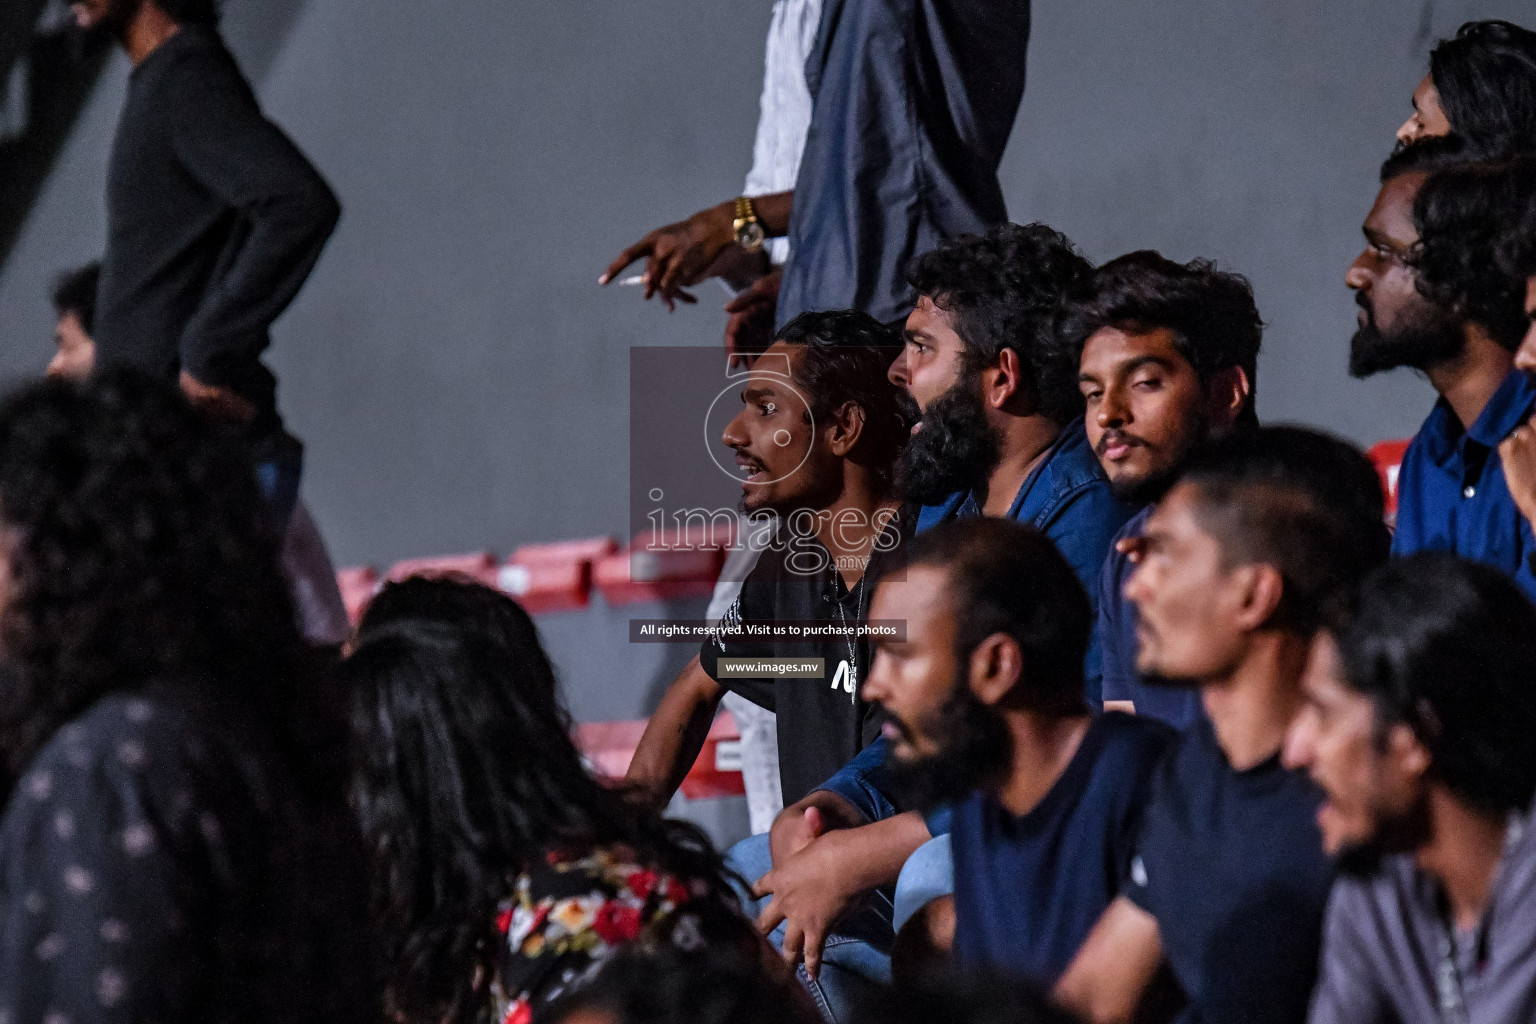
[{"left": 1430, "top": 21, "right": 1536, "bottom": 155}]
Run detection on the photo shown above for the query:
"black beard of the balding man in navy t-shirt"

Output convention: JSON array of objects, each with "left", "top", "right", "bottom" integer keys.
[{"left": 886, "top": 686, "right": 1012, "bottom": 811}]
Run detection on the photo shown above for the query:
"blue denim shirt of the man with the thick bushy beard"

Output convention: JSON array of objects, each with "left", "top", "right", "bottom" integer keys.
[{"left": 917, "top": 416, "right": 1135, "bottom": 708}]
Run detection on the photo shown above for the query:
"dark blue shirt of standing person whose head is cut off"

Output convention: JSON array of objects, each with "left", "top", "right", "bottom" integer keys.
[{"left": 777, "top": 0, "right": 1029, "bottom": 327}]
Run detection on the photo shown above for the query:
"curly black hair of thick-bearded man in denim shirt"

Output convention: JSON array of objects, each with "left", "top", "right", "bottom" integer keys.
[{"left": 906, "top": 224, "right": 1094, "bottom": 424}]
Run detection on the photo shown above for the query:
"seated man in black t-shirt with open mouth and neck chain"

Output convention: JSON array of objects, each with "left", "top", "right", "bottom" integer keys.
[{"left": 628, "top": 312, "right": 909, "bottom": 804}]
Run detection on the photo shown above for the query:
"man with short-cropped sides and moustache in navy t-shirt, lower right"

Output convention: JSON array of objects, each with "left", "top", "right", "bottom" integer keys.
[{"left": 1057, "top": 427, "right": 1389, "bottom": 1024}]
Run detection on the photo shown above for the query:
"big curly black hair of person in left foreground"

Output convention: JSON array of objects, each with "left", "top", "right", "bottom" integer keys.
[{"left": 0, "top": 370, "right": 317, "bottom": 792}]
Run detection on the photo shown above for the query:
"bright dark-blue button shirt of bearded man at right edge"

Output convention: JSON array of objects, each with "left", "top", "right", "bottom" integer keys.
[{"left": 1392, "top": 370, "right": 1536, "bottom": 599}]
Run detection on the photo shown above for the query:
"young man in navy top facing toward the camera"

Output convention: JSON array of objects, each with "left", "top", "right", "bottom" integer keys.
[{"left": 1057, "top": 252, "right": 1264, "bottom": 729}]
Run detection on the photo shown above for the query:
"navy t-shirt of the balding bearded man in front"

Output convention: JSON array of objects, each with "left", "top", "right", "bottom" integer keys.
[{"left": 949, "top": 712, "right": 1174, "bottom": 987}]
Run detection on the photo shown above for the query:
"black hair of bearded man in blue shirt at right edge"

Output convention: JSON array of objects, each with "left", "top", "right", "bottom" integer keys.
[{"left": 1381, "top": 138, "right": 1530, "bottom": 352}]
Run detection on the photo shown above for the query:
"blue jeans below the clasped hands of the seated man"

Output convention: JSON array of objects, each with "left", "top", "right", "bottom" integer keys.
[{"left": 725, "top": 834, "right": 894, "bottom": 1024}]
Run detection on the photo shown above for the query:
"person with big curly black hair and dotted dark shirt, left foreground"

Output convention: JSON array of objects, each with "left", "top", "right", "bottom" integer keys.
[{"left": 0, "top": 372, "right": 378, "bottom": 1024}]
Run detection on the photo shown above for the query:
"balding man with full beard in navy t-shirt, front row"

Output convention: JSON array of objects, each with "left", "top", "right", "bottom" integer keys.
[{"left": 865, "top": 517, "right": 1172, "bottom": 986}]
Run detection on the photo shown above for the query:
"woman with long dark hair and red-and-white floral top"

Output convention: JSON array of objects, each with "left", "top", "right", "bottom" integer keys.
[{"left": 341, "top": 579, "right": 763, "bottom": 1024}]
